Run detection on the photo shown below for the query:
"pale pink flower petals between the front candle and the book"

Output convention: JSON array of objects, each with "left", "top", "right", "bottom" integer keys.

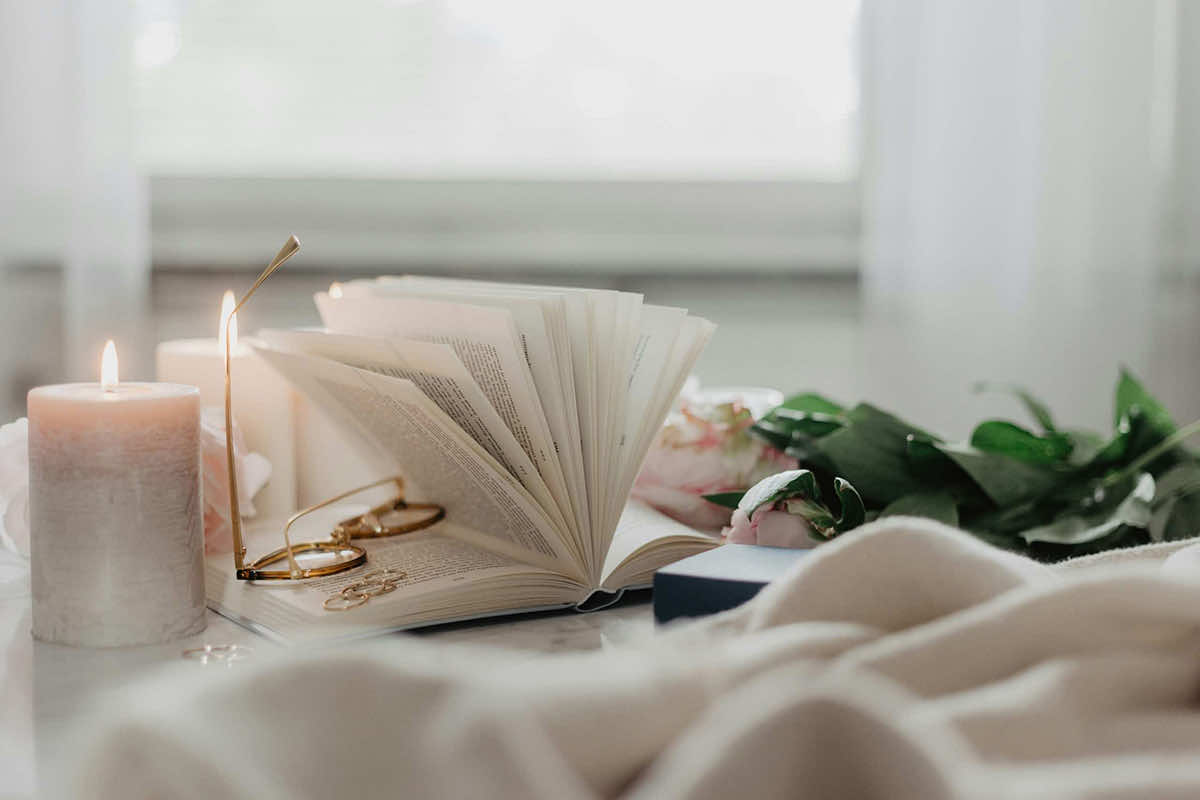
[{"left": 200, "top": 407, "right": 271, "bottom": 553}]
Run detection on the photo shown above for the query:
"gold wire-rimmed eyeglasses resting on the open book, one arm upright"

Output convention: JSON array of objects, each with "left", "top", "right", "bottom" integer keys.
[{"left": 223, "top": 236, "right": 445, "bottom": 582}]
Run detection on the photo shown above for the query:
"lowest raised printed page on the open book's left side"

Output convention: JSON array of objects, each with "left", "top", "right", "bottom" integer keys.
[{"left": 259, "top": 348, "right": 583, "bottom": 579}]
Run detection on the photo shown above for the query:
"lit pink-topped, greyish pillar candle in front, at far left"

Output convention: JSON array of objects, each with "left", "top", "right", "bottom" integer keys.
[{"left": 28, "top": 342, "right": 204, "bottom": 646}]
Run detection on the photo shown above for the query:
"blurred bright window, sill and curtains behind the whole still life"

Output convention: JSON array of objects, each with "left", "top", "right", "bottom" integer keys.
[{"left": 0, "top": 0, "right": 1200, "bottom": 435}]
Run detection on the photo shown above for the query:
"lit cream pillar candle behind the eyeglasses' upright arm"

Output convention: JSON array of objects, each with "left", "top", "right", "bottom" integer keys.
[{"left": 155, "top": 291, "right": 296, "bottom": 518}]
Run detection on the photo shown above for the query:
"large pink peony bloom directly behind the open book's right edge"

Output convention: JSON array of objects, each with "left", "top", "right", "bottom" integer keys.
[{"left": 632, "top": 390, "right": 796, "bottom": 530}]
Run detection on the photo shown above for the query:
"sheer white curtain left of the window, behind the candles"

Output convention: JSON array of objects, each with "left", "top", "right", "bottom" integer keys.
[{"left": 0, "top": 0, "right": 152, "bottom": 380}]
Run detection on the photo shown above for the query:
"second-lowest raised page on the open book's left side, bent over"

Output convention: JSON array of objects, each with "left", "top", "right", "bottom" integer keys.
[{"left": 259, "top": 330, "right": 568, "bottom": 542}]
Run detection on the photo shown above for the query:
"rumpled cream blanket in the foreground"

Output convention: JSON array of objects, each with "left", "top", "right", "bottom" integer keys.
[{"left": 73, "top": 519, "right": 1200, "bottom": 800}]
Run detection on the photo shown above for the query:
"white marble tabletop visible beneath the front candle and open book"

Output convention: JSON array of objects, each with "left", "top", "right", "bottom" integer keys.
[{"left": 0, "top": 582, "right": 654, "bottom": 800}]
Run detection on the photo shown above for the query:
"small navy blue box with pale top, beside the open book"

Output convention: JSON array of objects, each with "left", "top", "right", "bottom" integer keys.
[{"left": 654, "top": 545, "right": 811, "bottom": 622}]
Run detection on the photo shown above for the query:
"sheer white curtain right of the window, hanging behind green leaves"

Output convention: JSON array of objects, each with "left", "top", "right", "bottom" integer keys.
[{"left": 863, "top": 0, "right": 1200, "bottom": 438}]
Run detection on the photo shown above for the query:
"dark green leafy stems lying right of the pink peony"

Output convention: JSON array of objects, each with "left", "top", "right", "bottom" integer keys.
[{"left": 709, "top": 369, "right": 1200, "bottom": 560}]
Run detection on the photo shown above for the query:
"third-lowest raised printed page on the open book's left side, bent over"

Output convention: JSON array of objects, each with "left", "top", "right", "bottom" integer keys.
[{"left": 316, "top": 293, "right": 575, "bottom": 546}]
